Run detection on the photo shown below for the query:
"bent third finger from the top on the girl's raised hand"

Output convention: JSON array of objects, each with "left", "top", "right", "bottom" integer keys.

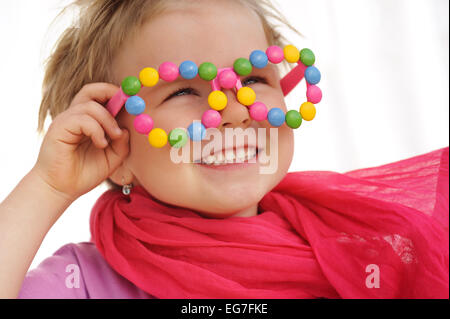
[{"left": 60, "top": 114, "right": 108, "bottom": 148}]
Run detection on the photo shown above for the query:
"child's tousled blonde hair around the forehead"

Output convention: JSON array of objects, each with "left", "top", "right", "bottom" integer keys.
[{"left": 38, "top": 0, "right": 301, "bottom": 133}]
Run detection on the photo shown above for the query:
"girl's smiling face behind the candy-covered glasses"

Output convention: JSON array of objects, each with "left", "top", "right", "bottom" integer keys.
[{"left": 111, "top": 0, "right": 293, "bottom": 217}]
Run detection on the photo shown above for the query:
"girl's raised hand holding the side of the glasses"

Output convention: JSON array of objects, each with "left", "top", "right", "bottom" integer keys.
[{"left": 33, "top": 83, "right": 129, "bottom": 201}]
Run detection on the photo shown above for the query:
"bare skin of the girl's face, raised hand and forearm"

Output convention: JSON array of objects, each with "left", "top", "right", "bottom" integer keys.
[{"left": 0, "top": 0, "right": 293, "bottom": 298}]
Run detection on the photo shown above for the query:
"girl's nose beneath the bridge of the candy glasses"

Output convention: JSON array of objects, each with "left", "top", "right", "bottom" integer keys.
[{"left": 217, "top": 90, "right": 252, "bottom": 130}]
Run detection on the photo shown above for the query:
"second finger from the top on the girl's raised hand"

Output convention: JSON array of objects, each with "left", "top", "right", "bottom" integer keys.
[{"left": 73, "top": 101, "right": 122, "bottom": 140}]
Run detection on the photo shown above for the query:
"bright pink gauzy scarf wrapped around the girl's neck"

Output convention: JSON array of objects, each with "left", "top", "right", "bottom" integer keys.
[{"left": 91, "top": 147, "right": 449, "bottom": 299}]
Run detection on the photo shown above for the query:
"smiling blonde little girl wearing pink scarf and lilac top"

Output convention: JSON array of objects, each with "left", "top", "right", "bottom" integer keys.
[{"left": 0, "top": 0, "right": 449, "bottom": 298}]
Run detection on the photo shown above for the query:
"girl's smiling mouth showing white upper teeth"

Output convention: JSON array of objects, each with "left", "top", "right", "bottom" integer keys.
[{"left": 194, "top": 146, "right": 261, "bottom": 166}]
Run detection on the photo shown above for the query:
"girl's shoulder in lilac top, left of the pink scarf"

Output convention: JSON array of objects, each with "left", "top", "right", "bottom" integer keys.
[{"left": 19, "top": 242, "right": 152, "bottom": 299}]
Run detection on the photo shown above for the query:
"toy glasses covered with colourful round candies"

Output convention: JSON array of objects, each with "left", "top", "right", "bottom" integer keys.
[{"left": 106, "top": 45, "right": 322, "bottom": 148}]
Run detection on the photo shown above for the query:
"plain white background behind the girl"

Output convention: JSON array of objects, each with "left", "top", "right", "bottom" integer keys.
[{"left": 0, "top": 0, "right": 449, "bottom": 268}]
